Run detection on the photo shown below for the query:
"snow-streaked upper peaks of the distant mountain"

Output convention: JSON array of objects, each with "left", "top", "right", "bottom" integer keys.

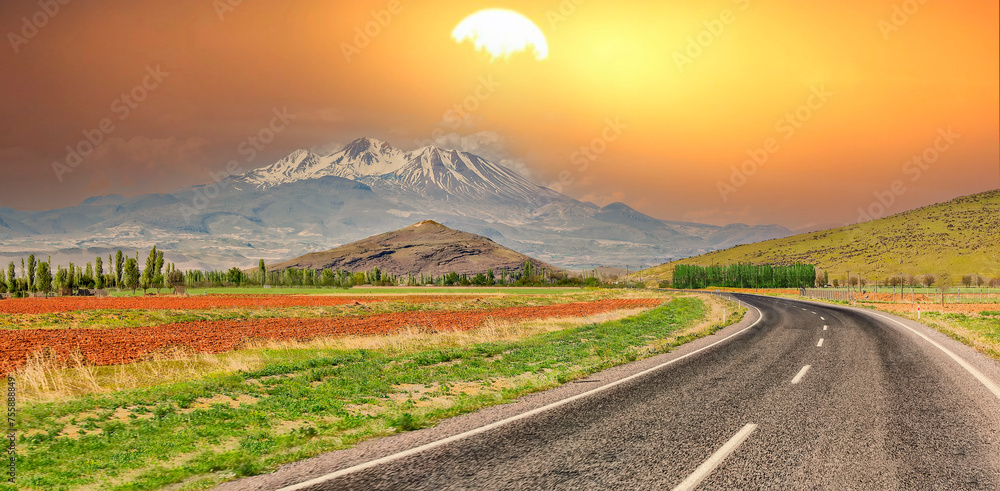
[{"left": 232, "top": 138, "right": 564, "bottom": 206}]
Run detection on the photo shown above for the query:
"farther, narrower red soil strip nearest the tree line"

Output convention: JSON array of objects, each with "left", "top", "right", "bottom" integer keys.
[{"left": 0, "top": 295, "right": 481, "bottom": 314}]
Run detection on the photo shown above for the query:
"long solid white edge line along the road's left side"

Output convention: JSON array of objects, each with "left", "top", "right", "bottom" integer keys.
[{"left": 278, "top": 304, "right": 764, "bottom": 491}]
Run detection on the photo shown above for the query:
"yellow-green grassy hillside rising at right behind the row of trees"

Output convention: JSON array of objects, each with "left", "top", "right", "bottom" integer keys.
[{"left": 641, "top": 191, "right": 1000, "bottom": 285}]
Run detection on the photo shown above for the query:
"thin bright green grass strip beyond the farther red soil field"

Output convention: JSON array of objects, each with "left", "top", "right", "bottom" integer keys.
[{"left": 110, "top": 286, "right": 583, "bottom": 297}]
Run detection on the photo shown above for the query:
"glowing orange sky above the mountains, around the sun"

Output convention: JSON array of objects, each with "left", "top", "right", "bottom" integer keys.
[{"left": 0, "top": 0, "right": 1000, "bottom": 229}]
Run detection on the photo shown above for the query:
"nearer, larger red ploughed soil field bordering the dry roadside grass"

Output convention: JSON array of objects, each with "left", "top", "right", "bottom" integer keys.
[{"left": 0, "top": 299, "right": 663, "bottom": 374}]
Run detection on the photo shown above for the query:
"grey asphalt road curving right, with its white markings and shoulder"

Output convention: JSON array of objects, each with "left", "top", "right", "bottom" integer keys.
[{"left": 222, "top": 295, "right": 1000, "bottom": 490}]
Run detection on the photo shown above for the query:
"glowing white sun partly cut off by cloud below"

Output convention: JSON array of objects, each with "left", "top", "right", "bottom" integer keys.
[{"left": 451, "top": 9, "right": 549, "bottom": 61}]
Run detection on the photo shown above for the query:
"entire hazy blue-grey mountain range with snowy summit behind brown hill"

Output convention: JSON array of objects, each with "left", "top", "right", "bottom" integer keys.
[{"left": 0, "top": 138, "right": 791, "bottom": 269}]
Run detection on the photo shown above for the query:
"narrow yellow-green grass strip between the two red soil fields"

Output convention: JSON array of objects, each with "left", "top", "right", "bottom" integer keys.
[{"left": 0, "top": 290, "right": 616, "bottom": 329}]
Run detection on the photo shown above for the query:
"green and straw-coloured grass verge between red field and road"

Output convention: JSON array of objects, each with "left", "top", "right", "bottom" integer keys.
[{"left": 0, "top": 295, "right": 742, "bottom": 490}]
